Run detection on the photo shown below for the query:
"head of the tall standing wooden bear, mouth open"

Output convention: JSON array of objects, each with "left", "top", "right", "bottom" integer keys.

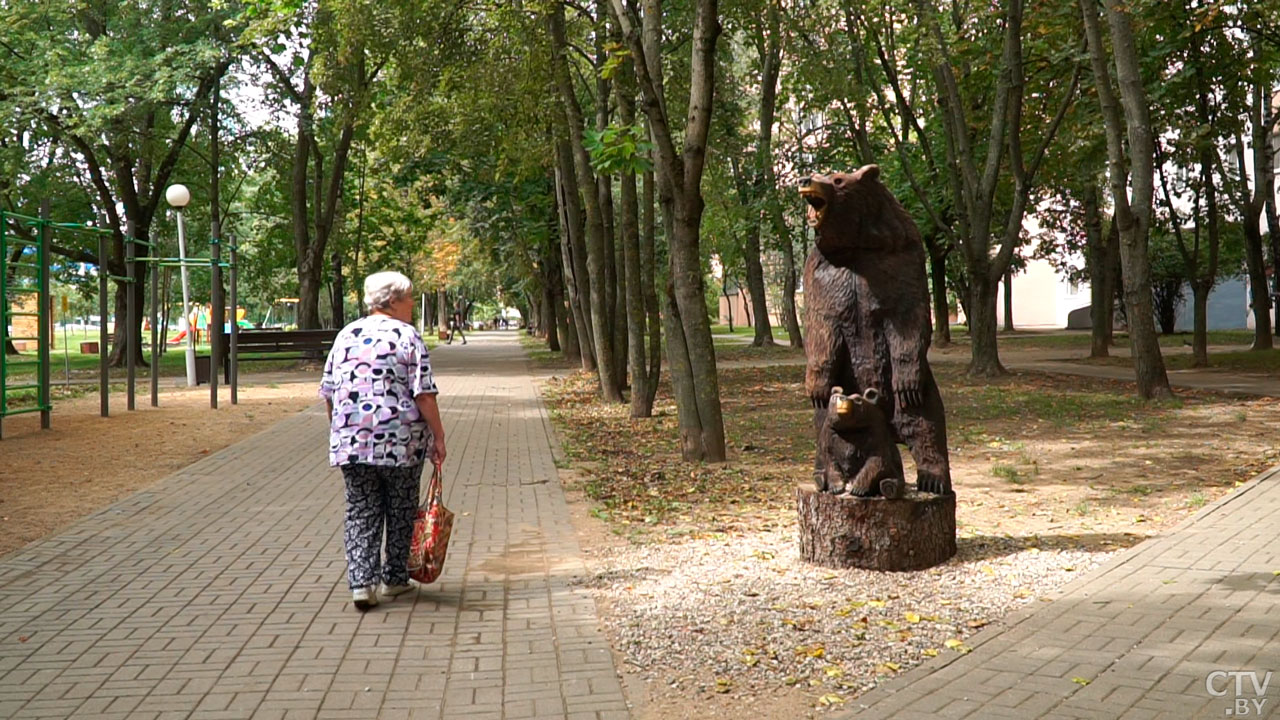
[{"left": 800, "top": 165, "right": 920, "bottom": 260}]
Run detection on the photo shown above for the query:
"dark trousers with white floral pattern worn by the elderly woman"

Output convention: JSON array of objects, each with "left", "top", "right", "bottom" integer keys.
[{"left": 342, "top": 462, "right": 422, "bottom": 589}]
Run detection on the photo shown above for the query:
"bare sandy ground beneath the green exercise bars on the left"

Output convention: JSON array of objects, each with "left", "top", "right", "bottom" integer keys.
[{"left": 0, "top": 373, "right": 317, "bottom": 556}]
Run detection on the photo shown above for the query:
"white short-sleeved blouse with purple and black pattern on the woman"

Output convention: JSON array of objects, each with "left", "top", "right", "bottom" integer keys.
[{"left": 320, "top": 315, "right": 439, "bottom": 466}]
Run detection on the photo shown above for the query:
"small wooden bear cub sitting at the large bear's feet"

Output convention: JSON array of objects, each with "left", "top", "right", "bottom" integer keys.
[{"left": 818, "top": 387, "right": 905, "bottom": 500}]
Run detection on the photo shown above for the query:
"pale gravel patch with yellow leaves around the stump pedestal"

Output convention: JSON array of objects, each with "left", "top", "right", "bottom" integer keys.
[{"left": 585, "top": 527, "right": 1111, "bottom": 707}]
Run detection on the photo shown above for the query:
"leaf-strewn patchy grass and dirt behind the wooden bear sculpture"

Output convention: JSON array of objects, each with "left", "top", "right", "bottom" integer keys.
[{"left": 547, "top": 365, "right": 1280, "bottom": 550}]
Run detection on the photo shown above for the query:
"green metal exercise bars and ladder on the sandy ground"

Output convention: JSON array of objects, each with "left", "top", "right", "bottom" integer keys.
[{"left": 0, "top": 201, "right": 243, "bottom": 438}]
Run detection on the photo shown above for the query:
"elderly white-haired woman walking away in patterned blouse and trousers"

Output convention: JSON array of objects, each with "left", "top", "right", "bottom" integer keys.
[{"left": 320, "top": 272, "right": 444, "bottom": 610}]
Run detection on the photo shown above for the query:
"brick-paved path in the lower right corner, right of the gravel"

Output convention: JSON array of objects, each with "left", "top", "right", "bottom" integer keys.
[{"left": 847, "top": 469, "right": 1280, "bottom": 720}]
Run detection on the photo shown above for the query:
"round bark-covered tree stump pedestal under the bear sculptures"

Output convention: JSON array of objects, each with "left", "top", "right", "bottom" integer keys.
[{"left": 796, "top": 483, "right": 956, "bottom": 570}]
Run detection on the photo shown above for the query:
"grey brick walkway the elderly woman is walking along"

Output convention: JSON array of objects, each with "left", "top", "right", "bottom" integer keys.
[{"left": 0, "top": 333, "right": 627, "bottom": 720}]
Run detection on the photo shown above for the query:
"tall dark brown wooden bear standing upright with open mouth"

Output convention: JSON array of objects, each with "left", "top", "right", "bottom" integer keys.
[{"left": 800, "top": 165, "right": 951, "bottom": 495}]
